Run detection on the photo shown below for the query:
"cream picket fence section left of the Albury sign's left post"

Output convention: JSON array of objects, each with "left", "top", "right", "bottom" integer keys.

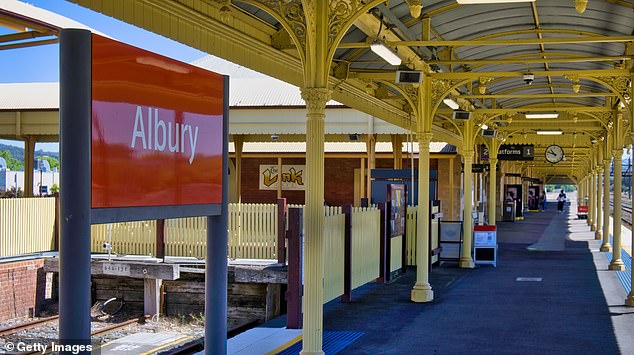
[{"left": 0, "top": 197, "right": 55, "bottom": 257}]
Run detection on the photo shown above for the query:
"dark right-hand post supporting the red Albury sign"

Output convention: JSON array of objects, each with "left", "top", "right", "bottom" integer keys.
[{"left": 205, "top": 76, "right": 229, "bottom": 355}]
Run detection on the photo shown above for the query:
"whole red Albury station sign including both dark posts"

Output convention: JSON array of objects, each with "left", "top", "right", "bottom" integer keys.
[{"left": 59, "top": 29, "right": 229, "bottom": 354}]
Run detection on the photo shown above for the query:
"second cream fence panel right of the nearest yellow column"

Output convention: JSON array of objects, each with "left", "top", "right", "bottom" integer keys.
[{"left": 351, "top": 207, "right": 381, "bottom": 289}]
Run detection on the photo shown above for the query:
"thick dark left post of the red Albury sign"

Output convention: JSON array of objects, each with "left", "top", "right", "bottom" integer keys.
[{"left": 59, "top": 29, "right": 92, "bottom": 345}]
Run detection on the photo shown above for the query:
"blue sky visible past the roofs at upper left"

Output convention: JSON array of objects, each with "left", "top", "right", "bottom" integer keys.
[{"left": 0, "top": 0, "right": 205, "bottom": 151}]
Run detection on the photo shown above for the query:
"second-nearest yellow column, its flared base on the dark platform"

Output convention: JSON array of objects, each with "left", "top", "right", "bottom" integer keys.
[{"left": 411, "top": 132, "right": 434, "bottom": 302}]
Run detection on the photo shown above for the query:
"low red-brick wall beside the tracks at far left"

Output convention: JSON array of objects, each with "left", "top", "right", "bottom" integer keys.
[{"left": 0, "top": 259, "right": 53, "bottom": 321}]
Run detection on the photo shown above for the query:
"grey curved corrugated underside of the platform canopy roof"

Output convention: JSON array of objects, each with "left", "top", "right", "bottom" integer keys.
[{"left": 328, "top": 0, "right": 634, "bottom": 107}]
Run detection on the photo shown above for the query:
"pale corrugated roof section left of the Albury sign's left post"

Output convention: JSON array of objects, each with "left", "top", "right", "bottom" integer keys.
[{"left": 0, "top": 83, "right": 59, "bottom": 110}]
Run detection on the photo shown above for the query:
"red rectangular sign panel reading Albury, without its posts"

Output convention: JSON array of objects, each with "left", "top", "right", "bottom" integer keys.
[{"left": 91, "top": 35, "right": 224, "bottom": 208}]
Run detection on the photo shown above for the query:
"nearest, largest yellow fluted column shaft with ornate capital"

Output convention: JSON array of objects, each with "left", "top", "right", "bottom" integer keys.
[{"left": 302, "top": 88, "right": 330, "bottom": 354}]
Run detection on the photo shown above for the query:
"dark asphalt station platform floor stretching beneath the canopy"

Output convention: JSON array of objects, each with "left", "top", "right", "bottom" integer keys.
[{"left": 228, "top": 205, "right": 634, "bottom": 355}]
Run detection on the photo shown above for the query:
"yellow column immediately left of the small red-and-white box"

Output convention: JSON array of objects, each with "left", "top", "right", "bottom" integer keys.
[{"left": 459, "top": 139, "right": 475, "bottom": 269}]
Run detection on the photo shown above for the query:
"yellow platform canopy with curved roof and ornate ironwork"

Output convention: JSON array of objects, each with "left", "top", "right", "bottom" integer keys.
[{"left": 48, "top": 0, "right": 634, "bottom": 184}]
